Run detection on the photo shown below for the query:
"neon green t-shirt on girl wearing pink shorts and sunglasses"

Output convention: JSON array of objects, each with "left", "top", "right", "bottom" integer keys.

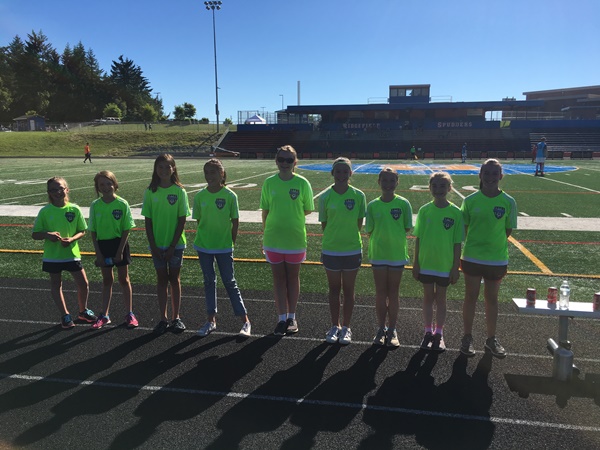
[{"left": 260, "top": 174, "right": 315, "bottom": 253}]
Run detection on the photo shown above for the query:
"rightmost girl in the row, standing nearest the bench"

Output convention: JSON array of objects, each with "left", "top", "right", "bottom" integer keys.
[{"left": 460, "top": 159, "right": 517, "bottom": 358}]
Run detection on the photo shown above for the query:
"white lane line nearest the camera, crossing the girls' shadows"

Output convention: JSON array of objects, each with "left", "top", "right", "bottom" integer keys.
[{"left": 0, "top": 373, "right": 600, "bottom": 432}]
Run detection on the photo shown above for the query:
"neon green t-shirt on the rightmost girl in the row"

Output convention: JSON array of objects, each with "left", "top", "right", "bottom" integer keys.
[{"left": 461, "top": 191, "right": 517, "bottom": 266}]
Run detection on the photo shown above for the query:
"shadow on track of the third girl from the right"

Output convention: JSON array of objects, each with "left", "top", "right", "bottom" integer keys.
[{"left": 281, "top": 345, "right": 388, "bottom": 450}]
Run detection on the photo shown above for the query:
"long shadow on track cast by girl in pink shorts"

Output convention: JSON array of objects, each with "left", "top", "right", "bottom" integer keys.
[{"left": 109, "top": 336, "right": 280, "bottom": 449}]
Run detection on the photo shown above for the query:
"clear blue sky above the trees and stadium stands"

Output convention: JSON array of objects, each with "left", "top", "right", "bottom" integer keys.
[{"left": 0, "top": 0, "right": 600, "bottom": 123}]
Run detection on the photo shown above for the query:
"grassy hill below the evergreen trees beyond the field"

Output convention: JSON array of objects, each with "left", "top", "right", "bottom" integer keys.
[{"left": 0, "top": 124, "right": 230, "bottom": 157}]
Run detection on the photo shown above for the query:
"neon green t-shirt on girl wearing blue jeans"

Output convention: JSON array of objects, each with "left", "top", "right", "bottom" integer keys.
[{"left": 192, "top": 186, "right": 240, "bottom": 253}]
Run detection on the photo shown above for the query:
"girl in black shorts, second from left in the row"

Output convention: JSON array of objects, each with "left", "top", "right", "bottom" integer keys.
[{"left": 89, "top": 170, "right": 138, "bottom": 330}]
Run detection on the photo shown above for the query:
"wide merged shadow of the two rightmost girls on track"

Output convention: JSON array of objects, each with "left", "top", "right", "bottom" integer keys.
[{"left": 358, "top": 350, "right": 495, "bottom": 450}]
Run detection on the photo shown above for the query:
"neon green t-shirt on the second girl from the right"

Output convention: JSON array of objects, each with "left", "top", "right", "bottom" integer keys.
[{"left": 413, "top": 202, "right": 465, "bottom": 277}]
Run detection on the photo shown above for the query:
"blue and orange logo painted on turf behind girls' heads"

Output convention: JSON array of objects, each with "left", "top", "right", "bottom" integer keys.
[{"left": 298, "top": 161, "right": 577, "bottom": 175}]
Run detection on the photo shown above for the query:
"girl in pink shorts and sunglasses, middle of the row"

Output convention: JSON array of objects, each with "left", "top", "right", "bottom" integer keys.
[{"left": 260, "top": 145, "right": 315, "bottom": 336}]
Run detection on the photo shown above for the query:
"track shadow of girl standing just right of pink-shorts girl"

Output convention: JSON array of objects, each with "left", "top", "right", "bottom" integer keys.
[{"left": 206, "top": 342, "right": 340, "bottom": 450}]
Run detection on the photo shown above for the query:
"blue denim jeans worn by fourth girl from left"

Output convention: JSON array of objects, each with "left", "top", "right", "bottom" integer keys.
[{"left": 198, "top": 252, "right": 247, "bottom": 316}]
